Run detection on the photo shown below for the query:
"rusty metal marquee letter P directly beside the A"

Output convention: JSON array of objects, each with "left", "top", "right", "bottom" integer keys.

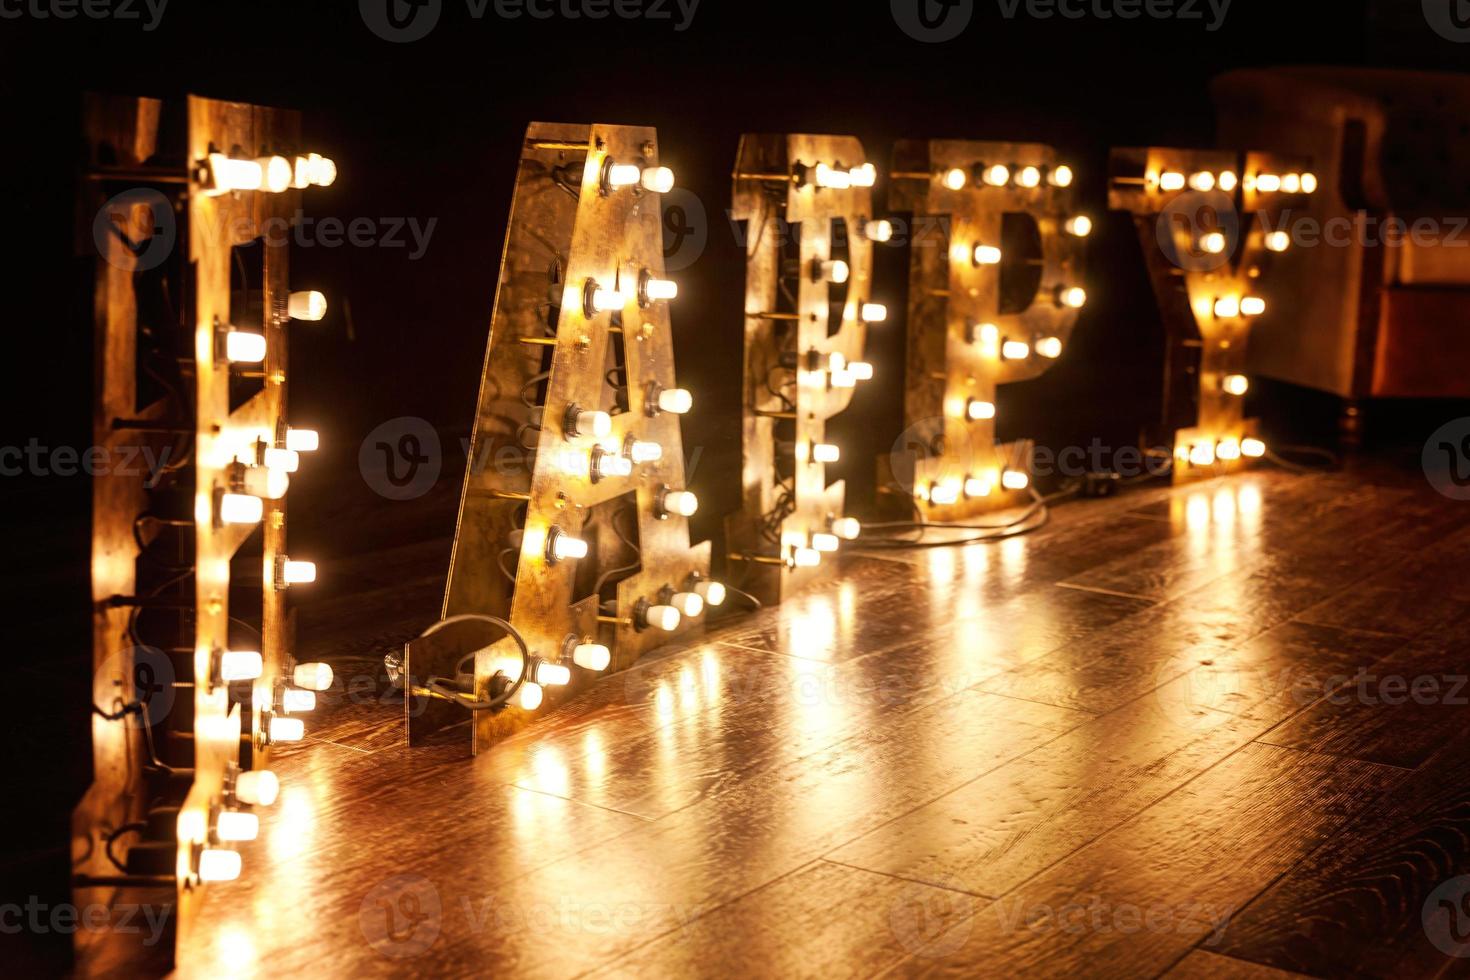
[{"left": 725, "top": 134, "right": 875, "bottom": 602}]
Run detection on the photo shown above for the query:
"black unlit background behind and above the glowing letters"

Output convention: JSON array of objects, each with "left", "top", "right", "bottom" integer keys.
[{"left": 0, "top": 0, "right": 1470, "bottom": 963}]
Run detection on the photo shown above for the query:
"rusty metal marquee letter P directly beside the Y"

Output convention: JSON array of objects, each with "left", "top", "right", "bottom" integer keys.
[{"left": 879, "top": 140, "right": 1086, "bottom": 522}]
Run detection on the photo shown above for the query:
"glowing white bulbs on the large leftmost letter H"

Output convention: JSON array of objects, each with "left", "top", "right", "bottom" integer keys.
[{"left": 189, "top": 153, "right": 337, "bottom": 882}]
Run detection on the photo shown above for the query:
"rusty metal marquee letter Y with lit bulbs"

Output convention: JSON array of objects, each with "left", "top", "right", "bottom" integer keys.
[{"left": 1108, "top": 147, "right": 1320, "bottom": 482}]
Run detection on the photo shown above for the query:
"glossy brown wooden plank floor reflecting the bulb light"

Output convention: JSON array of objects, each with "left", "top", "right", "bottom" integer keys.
[{"left": 179, "top": 470, "right": 1470, "bottom": 977}]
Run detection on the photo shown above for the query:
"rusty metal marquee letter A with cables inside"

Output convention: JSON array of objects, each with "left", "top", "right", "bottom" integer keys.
[{"left": 438, "top": 122, "right": 710, "bottom": 749}]
